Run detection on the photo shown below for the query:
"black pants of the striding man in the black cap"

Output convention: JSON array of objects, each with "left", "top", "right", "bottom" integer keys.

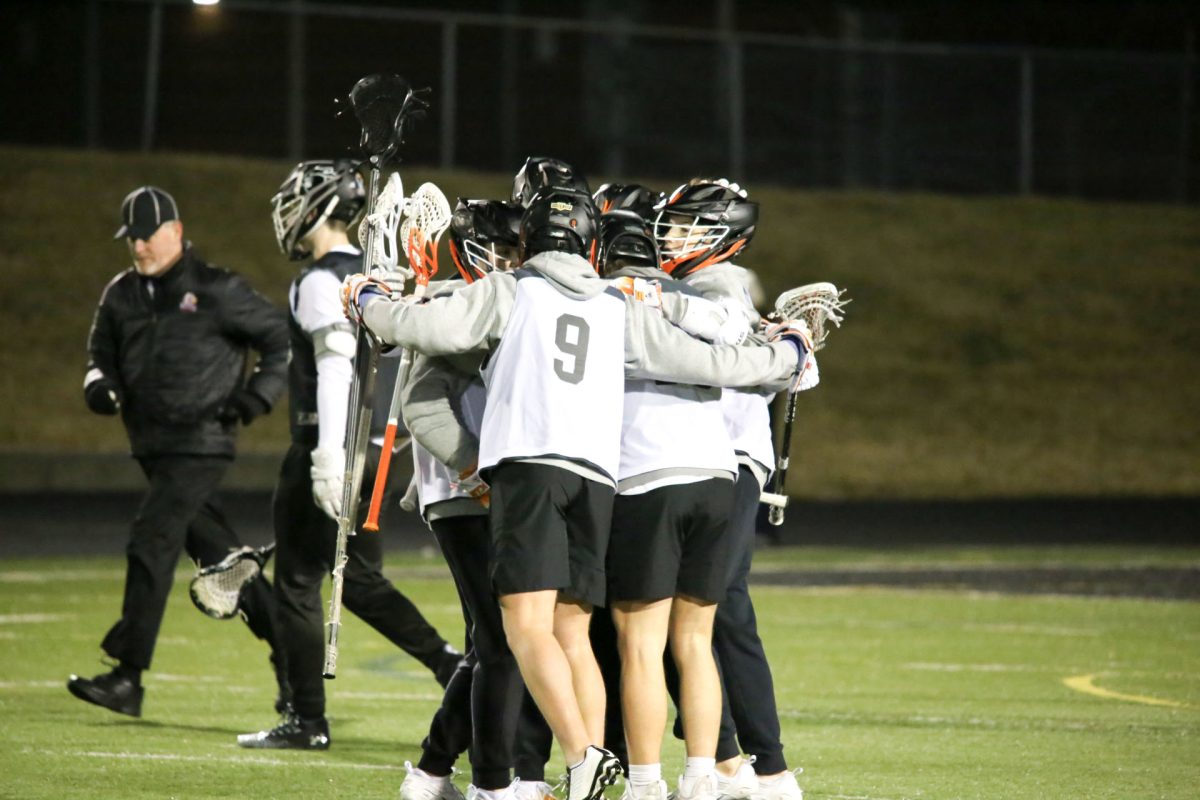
[{"left": 101, "top": 456, "right": 278, "bottom": 669}]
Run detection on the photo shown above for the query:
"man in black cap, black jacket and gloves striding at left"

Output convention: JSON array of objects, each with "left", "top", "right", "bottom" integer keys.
[{"left": 67, "top": 186, "right": 288, "bottom": 716}]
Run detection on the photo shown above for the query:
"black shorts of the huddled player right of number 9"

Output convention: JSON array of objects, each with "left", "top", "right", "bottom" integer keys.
[{"left": 608, "top": 479, "right": 733, "bottom": 602}]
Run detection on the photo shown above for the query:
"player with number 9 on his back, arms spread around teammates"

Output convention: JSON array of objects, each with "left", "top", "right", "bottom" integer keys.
[{"left": 343, "top": 188, "right": 808, "bottom": 800}]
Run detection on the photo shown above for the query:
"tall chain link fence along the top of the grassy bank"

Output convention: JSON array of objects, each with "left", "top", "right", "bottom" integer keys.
[{"left": 0, "top": 0, "right": 1200, "bottom": 203}]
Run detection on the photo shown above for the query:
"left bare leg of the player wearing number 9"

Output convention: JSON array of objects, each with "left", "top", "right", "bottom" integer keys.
[{"left": 500, "top": 589, "right": 590, "bottom": 764}]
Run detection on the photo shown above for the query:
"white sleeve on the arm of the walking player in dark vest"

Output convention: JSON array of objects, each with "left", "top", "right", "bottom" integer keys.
[{"left": 295, "top": 270, "right": 354, "bottom": 450}]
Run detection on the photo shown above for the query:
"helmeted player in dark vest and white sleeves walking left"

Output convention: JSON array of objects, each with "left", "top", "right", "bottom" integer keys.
[{"left": 238, "top": 161, "right": 461, "bottom": 750}]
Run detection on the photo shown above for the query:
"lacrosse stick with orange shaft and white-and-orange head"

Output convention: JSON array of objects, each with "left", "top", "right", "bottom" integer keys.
[{"left": 362, "top": 184, "right": 450, "bottom": 530}]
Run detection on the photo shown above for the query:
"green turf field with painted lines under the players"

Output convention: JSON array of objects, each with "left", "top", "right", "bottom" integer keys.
[{"left": 0, "top": 547, "right": 1200, "bottom": 800}]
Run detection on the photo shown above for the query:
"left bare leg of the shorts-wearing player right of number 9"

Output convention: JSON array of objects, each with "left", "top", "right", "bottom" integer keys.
[{"left": 612, "top": 599, "right": 672, "bottom": 764}]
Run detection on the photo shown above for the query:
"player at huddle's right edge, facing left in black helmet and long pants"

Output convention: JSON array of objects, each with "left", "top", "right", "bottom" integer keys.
[{"left": 654, "top": 179, "right": 815, "bottom": 800}]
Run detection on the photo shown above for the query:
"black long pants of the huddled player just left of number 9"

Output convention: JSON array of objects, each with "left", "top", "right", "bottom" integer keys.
[{"left": 418, "top": 516, "right": 523, "bottom": 789}]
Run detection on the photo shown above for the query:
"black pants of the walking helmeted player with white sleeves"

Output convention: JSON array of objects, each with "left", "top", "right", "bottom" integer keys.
[{"left": 274, "top": 444, "right": 458, "bottom": 718}]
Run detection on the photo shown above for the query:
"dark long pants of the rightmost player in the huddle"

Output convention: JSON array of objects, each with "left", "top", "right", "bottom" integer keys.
[{"left": 713, "top": 467, "right": 787, "bottom": 775}]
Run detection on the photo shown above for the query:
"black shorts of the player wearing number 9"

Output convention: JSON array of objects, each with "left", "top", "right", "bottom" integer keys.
[{"left": 487, "top": 462, "right": 616, "bottom": 606}]
